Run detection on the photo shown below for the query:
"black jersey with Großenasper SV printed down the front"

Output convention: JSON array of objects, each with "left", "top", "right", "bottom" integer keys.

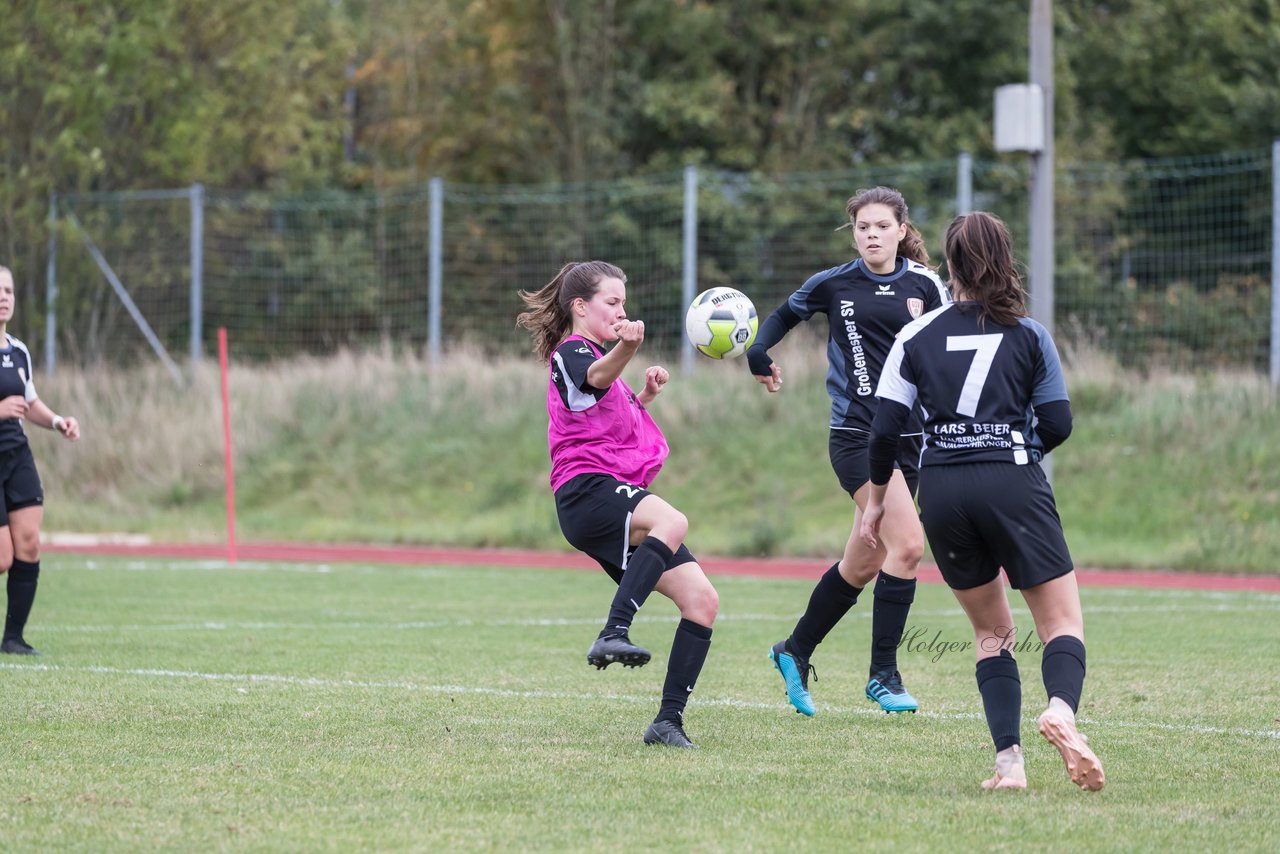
[{"left": 787, "top": 257, "right": 951, "bottom": 431}]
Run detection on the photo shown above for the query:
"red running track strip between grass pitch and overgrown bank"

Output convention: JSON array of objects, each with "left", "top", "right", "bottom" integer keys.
[{"left": 42, "top": 543, "right": 1280, "bottom": 593}]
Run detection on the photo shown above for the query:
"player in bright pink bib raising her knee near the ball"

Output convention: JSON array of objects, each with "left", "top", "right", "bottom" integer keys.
[{"left": 517, "top": 261, "right": 719, "bottom": 748}]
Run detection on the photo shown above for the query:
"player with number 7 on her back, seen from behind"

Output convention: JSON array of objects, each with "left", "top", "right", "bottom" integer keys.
[{"left": 860, "top": 213, "right": 1105, "bottom": 791}]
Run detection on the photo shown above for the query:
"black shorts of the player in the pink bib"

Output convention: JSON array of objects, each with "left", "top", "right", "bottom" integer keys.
[{"left": 556, "top": 474, "right": 695, "bottom": 583}]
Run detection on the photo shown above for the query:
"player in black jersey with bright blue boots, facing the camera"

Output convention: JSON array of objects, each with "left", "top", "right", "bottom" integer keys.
[{"left": 746, "top": 187, "right": 948, "bottom": 714}]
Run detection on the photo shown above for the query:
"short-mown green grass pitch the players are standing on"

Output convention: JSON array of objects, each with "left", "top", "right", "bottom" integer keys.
[{"left": 0, "top": 554, "right": 1280, "bottom": 851}]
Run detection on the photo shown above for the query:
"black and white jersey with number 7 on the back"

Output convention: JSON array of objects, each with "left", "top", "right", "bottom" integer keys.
[{"left": 876, "top": 302, "right": 1068, "bottom": 467}]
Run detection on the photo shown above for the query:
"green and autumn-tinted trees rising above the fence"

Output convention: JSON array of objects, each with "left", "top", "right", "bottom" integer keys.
[{"left": 0, "top": 0, "right": 1280, "bottom": 363}]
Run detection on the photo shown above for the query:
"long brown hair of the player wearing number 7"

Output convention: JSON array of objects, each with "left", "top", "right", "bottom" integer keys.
[{"left": 946, "top": 211, "right": 1027, "bottom": 326}]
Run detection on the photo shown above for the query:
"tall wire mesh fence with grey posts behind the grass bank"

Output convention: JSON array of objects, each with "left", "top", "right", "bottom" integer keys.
[{"left": 42, "top": 150, "right": 1277, "bottom": 375}]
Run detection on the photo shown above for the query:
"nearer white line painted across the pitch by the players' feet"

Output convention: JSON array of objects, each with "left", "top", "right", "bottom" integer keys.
[{"left": 0, "top": 662, "right": 1280, "bottom": 740}]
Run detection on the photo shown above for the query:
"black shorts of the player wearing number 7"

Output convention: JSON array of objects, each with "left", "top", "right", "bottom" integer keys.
[{"left": 920, "top": 462, "right": 1075, "bottom": 590}]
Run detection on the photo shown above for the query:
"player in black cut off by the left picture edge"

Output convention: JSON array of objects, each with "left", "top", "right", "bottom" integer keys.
[{"left": 0, "top": 266, "right": 79, "bottom": 656}]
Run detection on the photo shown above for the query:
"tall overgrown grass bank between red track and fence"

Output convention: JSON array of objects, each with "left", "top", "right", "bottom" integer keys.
[{"left": 32, "top": 345, "right": 1280, "bottom": 575}]
